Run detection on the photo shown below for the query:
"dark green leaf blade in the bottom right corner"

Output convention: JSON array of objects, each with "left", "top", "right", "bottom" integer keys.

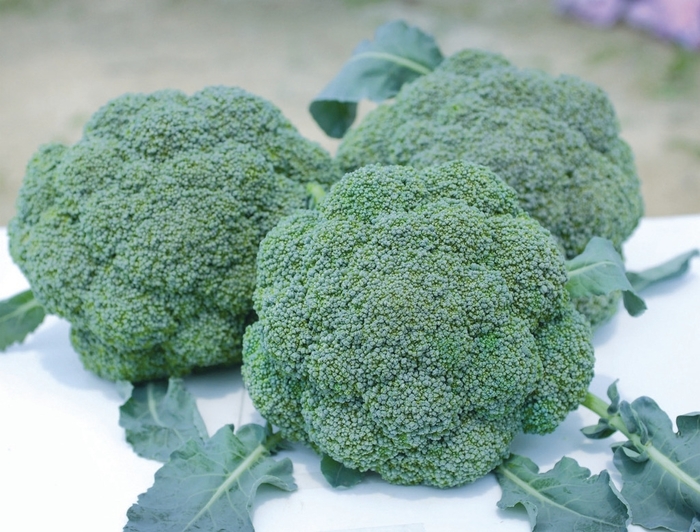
[{"left": 614, "top": 397, "right": 700, "bottom": 532}]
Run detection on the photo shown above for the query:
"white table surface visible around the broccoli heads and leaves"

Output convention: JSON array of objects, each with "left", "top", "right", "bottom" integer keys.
[{"left": 0, "top": 215, "right": 700, "bottom": 532}]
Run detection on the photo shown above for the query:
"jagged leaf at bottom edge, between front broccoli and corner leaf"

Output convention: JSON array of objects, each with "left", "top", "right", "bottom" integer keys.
[{"left": 495, "top": 455, "right": 629, "bottom": 532}]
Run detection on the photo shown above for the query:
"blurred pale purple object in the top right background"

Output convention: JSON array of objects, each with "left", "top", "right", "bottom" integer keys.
[{"left": 555, "top": 0, "right": 700, "bottom": 49}]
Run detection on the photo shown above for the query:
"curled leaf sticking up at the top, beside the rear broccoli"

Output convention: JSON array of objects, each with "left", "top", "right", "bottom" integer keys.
[{"left": 309, "top": 21, "right": 443, "bottom": 138}]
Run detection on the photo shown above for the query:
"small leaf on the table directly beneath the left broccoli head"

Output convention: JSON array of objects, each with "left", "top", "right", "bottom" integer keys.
[{"left": 119, "top": 379, "right": 208, "bottom": 462}]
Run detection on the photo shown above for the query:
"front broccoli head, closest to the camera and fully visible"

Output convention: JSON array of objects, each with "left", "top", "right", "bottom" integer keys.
[{"left": 243, "top": 162, "right": 593, "bottom": 487}]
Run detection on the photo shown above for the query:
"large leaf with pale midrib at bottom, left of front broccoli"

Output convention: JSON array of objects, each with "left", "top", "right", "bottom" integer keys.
[{"left": 124, "top": 425, "right": 296, "bottom": 532}]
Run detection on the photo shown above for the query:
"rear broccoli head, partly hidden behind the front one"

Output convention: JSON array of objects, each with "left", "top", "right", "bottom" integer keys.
[{"left": 337, "top": 50, "right": 643, "bottom": 324}]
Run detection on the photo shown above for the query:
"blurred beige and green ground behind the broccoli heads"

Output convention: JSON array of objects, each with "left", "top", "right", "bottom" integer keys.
[{"left": 0, "top": 0, "right": 700, "bottom": 226}]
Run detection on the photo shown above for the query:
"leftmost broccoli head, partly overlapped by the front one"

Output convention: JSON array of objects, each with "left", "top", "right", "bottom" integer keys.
[{"left": 9, "top": 87, "right": 338, "bottom": 381}]
